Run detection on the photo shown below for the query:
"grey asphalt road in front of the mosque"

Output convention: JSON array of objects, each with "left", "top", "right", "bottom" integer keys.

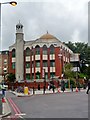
[{"left": 7, "top": 92, "right": 88, "bottom": 118}]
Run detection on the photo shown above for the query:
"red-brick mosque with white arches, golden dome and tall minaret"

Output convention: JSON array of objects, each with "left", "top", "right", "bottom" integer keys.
[{"left": 9, "top": 22, "right": 77, "bottom": 81}]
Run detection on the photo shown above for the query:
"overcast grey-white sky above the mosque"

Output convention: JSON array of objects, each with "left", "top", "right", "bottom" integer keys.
[{"left": 1, "top": 0, "right": 88, "bottom": 50}]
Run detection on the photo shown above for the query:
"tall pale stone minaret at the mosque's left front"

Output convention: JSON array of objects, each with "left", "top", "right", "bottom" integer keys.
[{"left": 16, "top": 22, "right": 24, "bottom": 81}]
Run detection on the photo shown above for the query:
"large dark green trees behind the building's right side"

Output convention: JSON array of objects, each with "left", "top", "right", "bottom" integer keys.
[{"left": 64, "top": 41, "right": 90, "bottom": 78}]
